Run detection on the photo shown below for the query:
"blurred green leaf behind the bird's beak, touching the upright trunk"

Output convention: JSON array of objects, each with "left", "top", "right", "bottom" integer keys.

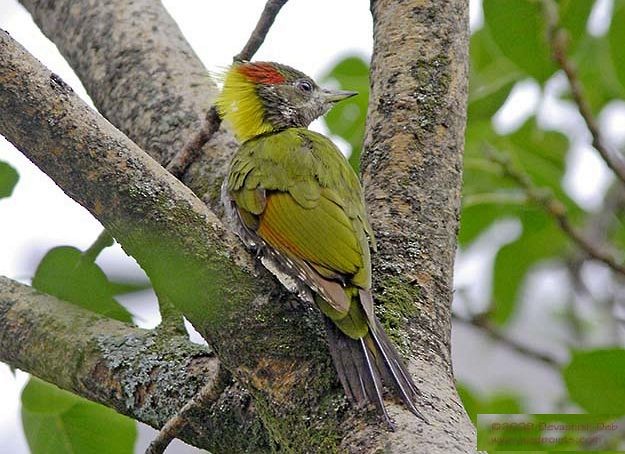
[{"left": 323, "top": 57, "right": 369, "bottom": 172}]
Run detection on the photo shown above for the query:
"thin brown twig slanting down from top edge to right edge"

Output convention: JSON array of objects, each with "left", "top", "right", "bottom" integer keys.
[{"left": 542, "top": 0, "right": 625, "bottom": 183}]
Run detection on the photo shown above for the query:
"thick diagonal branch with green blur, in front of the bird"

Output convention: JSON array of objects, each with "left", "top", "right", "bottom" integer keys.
[{"left": 0, "top": 27, "right": 384, "bottom": 451}]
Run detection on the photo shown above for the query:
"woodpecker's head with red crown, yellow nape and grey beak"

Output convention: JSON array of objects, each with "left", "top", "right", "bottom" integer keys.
[{"left": 216, "top": 62, "right": 357, "bottom": 141}]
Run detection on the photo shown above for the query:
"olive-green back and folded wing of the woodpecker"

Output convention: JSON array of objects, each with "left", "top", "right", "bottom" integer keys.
[{"left": 228, "top": 128, "right": 372, "bottom": 313}]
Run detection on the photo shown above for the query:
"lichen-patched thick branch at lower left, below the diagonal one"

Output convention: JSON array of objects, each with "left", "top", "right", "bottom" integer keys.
[{"left": 0, "top": 277, "right": 268, "bottom": 452}]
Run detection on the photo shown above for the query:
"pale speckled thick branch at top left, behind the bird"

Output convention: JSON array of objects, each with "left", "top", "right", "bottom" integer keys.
[{"left": 21, "top": 0, "right": 234, "bottom": 214}]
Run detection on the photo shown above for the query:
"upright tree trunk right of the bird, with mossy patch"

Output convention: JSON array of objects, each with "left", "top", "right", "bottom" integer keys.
[{"left": 361, "top": 0, "right": 475, "bottom": 453}]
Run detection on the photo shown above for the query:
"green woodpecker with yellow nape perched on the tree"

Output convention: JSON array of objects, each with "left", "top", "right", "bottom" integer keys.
[{"left": 215, "top": 61, "right": 426, "bottom": 430}]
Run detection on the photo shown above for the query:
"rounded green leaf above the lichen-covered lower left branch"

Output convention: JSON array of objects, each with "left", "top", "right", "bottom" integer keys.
[{"left": 32, "top": 246, "right": 132, "bottom": 322}]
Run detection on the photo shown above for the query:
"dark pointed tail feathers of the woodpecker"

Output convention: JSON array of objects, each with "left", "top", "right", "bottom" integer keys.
[{"left": 326, "top": 316, "right": 427, "bottom": 428}]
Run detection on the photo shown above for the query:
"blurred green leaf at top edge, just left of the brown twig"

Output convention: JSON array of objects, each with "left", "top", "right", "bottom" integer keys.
[{"left": 483, "top": 0, "right": 556, "bottom": 83}]
